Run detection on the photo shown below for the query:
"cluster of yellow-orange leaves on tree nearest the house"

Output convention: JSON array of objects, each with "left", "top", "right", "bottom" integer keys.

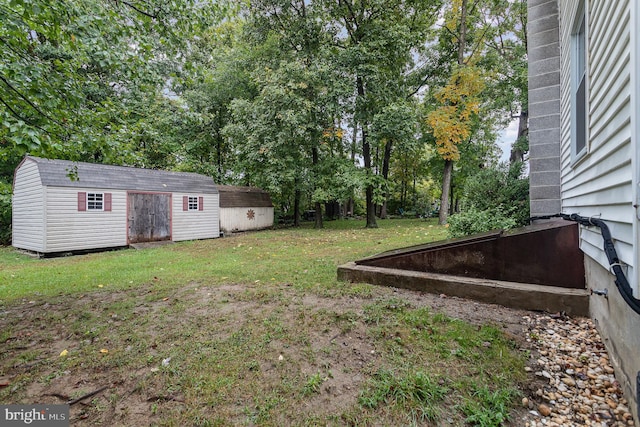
[{"left": 427, "top": 66, "right": 484, "bottom": 161}]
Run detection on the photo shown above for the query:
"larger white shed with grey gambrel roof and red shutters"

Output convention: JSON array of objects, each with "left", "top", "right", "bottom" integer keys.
[{"left": 12, "top": 156, "right": 220, "bottom": 254}]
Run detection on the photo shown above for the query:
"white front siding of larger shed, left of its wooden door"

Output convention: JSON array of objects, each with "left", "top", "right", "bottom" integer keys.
[{"left": 45, "top": 187, "right": 127, "bottom": 252}]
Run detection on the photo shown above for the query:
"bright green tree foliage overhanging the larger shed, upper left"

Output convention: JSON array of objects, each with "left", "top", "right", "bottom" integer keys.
[{"left": 0, "top": 0, "right": 220, "bottom": 160}]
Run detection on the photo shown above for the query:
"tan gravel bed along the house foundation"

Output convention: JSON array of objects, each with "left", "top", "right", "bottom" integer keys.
[{"left": 517, "top": 315, "right": 635, "bottom": 427}]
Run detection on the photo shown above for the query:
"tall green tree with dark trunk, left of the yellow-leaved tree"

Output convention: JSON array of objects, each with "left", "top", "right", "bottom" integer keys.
[{"left": 326, "top": 0, "right": 438, "bottom": 228}]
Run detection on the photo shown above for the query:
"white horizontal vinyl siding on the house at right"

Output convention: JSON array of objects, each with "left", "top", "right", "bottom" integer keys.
[{"left": 558, "top": 0, "right": 637, "bottom": 290}]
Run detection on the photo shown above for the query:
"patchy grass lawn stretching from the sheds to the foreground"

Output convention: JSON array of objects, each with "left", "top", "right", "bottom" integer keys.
[{"left": 0, "top": 220, "right": 525, "bottom": 426}]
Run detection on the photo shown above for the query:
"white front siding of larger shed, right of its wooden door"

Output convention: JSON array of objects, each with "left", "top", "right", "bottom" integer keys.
[{"left": 171, "top": 193, "right": 220, "bottom": 242}]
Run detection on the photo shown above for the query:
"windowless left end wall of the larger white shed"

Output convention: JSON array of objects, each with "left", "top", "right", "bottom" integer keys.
[{"left": 12, "top": 160, "right": 45, "bottom": 252}]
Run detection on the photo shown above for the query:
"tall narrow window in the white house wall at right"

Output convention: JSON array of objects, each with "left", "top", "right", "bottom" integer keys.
[{"left": 571, "top": 4, "right": 588, "bottom": 161}]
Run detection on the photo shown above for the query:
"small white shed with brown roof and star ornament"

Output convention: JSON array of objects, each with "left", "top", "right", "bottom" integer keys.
[{"left": 218, "top": 185, "right": 273, "bottom": 233}]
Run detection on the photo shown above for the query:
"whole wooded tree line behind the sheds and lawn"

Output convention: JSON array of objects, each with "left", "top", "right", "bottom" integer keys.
[{"left": 0, "top": 0, "right": 528, "bottom": 243}]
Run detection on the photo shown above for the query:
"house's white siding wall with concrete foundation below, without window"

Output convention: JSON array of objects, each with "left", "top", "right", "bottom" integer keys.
[{"left": 558, "top": 0, "right": 640, "bottom": 425}]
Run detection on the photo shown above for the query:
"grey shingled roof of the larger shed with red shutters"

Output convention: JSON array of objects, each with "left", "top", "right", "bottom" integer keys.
[{"left": 23, "top": 156, "right": 218, "bottom": 194}]
